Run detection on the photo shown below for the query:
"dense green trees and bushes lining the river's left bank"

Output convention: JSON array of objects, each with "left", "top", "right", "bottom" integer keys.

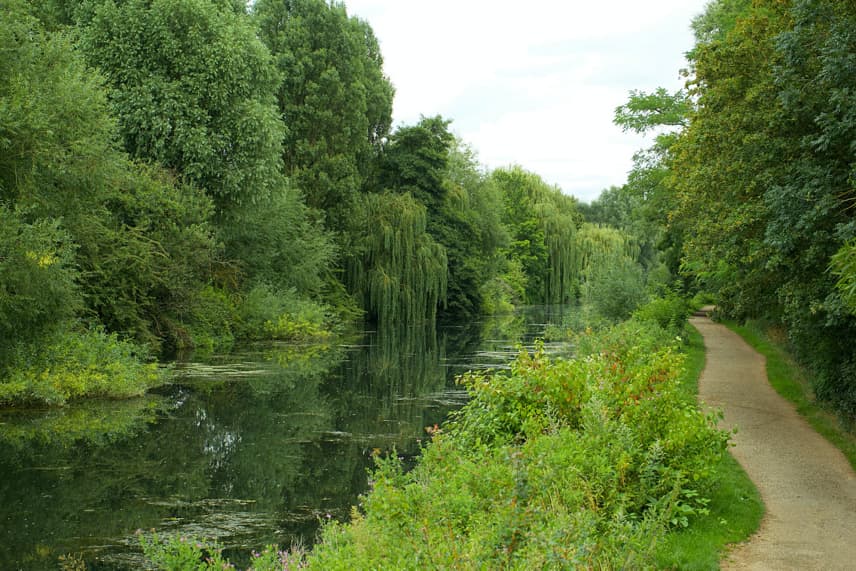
[{"left": 0, "top": 0, "right": 663, "bottom": 403}]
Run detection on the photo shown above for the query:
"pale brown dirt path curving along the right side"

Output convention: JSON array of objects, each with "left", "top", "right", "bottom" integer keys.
[{"left": 690, "top": 317, "right": 856, "bottom": 571}]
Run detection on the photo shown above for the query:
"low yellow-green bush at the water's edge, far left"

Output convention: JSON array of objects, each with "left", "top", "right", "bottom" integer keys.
[{"left": 0, "top": 329, "right": 167, "bottom": 405}]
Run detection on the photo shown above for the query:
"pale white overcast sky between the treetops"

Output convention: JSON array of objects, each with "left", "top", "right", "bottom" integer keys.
[{"left": 345, "top": 0, "right": 707, "bottom": 202}]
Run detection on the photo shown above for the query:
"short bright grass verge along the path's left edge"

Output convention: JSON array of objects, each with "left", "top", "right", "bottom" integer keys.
[{"left": 657, "top": 328, "right": 764, "bottom": 570}]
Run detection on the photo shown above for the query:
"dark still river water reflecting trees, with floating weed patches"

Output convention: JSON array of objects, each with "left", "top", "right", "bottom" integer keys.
[{"left": 0, "top": 308, "right": 568, "bottom": 570}]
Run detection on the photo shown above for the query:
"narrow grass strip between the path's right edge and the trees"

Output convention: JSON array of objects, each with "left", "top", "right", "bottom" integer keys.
[{"left": 725, "top": 322, "right": 856, "bottom": 470}]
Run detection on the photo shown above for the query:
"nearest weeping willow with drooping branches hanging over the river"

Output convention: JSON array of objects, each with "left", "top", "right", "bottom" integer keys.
[{"left": 348, "top": 193, "right": 448, "bottom": 326}]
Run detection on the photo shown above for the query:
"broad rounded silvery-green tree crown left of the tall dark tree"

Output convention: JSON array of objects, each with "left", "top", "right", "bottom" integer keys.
[{"left": 80, "top": 0, "right": 285, "bottom": 212}]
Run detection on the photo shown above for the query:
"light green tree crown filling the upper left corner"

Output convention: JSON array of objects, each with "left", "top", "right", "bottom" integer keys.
[{"left": 0, "top": 0, "right": 124, "bottom": 217}]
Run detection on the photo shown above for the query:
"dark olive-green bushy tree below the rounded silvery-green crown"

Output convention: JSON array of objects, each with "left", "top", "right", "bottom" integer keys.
[{"left": 83, "top": 165, "right": 219, "bottom": 348}]
